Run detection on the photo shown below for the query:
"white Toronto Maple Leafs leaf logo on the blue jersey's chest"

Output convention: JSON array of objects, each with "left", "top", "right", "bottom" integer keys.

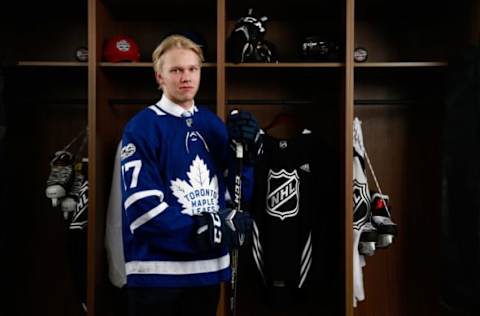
[{"left": 170, "top": 156, "right": 218, "bottom": 216}]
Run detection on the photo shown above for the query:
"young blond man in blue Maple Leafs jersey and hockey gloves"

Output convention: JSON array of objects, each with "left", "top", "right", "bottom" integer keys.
[{"left": 121, "top": 35, "right": 259, "bottom": 316}]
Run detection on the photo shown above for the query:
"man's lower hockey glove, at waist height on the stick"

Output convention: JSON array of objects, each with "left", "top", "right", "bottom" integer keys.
[{"left": 194, "top": 208, "right": 252, "bottom": 251}]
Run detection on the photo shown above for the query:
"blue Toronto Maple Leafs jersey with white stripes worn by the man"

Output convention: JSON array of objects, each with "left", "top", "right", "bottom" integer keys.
[{"left": 121, "top": 96, "right": 253, "bottom": 287}]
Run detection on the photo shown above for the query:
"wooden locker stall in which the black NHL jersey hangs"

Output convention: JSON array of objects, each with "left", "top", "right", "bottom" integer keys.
[{"left": 225, "top": 0, "right": 346, "bottom": 315}]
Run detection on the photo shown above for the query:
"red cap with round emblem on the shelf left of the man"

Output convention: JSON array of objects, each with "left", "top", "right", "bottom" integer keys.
[{"left": 103, "top": 35, "right": 140, "bottom": 63}]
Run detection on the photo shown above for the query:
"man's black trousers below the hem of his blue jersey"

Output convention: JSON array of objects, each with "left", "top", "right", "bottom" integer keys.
[{"left": 127, "top": 284, "right": 220, "bottom": 316}]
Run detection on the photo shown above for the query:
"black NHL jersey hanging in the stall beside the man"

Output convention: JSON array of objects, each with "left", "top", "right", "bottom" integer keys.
[{"left": 252, "top": 129, "right": 318, "bottom": 288}]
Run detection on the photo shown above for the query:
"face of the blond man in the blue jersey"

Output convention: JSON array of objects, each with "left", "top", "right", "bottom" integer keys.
[{"left": 155, "top": 48, "right": 200, "bottom": 109}]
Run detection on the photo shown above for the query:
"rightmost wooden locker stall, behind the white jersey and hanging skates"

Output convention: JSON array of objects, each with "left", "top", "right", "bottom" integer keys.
[{"left": 354, "top": 1, "right": 478, "bottom": 316}]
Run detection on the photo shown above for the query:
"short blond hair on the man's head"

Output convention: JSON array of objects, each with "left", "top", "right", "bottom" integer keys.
[{"left": 152, "top": 34, "right": 204, "bottom": 72}]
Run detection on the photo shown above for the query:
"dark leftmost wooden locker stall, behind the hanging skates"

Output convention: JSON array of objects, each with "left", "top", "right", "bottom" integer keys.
[{"left": 0, "top": 0, "right": 87, "bottom": 315}]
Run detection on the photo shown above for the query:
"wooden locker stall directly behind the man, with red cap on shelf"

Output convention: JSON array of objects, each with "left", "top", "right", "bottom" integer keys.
[{"left": 88, "top": 0, "right": 216, "bottom": 315}]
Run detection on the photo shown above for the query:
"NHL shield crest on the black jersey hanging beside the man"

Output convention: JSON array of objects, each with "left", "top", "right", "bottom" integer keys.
[{"left": 267, "top": 169, "right": 300, "bottom": 221}]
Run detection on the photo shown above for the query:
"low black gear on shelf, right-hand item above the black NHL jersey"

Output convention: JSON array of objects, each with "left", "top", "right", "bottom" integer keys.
[{"left": 300, "top": 36, "right": 340, "bottom": 61}]
